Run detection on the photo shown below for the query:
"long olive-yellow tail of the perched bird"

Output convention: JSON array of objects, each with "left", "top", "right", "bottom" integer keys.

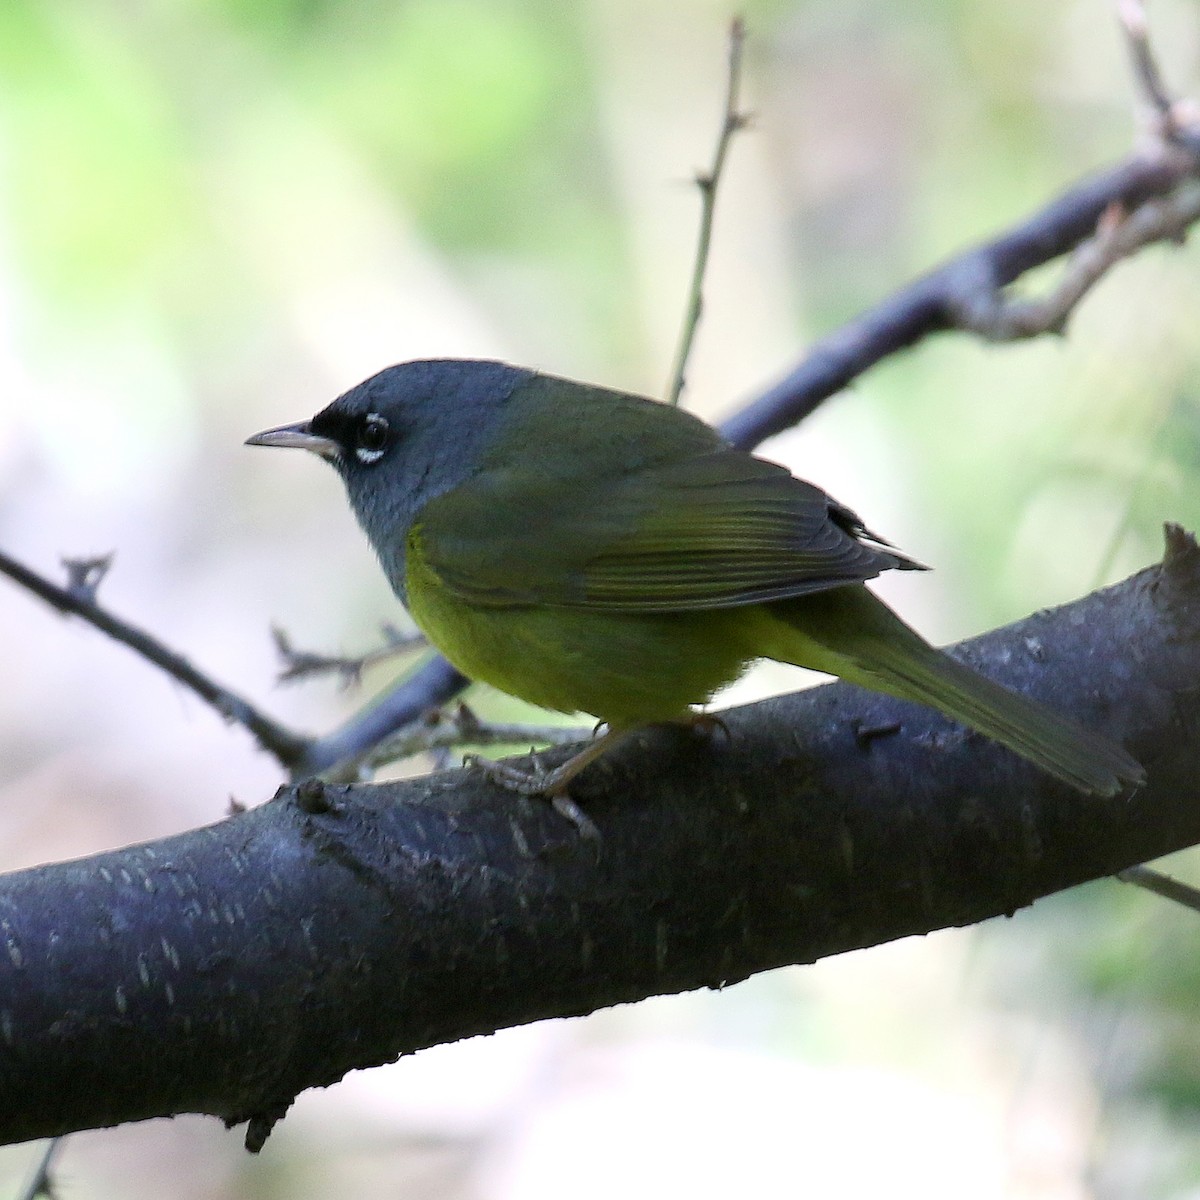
[{"left": 767, "top": 586, "right": 1146, "bottom": 796}]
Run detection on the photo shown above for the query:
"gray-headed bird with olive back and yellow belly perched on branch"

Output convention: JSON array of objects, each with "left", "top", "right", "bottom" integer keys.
[{"left": 248, "top": 359, "right": 1145, "bottom": 811}]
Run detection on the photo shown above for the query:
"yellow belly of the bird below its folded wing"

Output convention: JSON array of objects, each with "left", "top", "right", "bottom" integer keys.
[{"left": 407, "top": 540, "right": 756, "bottom": 728}]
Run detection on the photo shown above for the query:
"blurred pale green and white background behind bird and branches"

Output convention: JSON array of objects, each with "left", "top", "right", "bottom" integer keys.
[{"left": 0, "top": 0, "right": 1200, "bottom": 1200}]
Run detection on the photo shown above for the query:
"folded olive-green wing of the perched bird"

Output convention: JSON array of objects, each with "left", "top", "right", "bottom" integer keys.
[{"left": 413, "top": 444, "right": 919, "bottom": 612}]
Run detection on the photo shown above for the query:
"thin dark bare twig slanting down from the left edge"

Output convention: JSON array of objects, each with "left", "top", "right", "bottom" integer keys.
[{"left": 0, "top": 552, "right": 307, "bottom": 767}]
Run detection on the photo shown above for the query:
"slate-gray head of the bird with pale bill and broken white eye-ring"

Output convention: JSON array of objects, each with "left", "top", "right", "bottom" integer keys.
[{"left": 246, "top": 359, "right": 533, "bottom": 600}]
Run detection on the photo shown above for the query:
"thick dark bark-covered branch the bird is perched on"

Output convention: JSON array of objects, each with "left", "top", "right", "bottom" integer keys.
[{"left": 0, "top": 530, "right": 1200, "bottom": 1147}]
